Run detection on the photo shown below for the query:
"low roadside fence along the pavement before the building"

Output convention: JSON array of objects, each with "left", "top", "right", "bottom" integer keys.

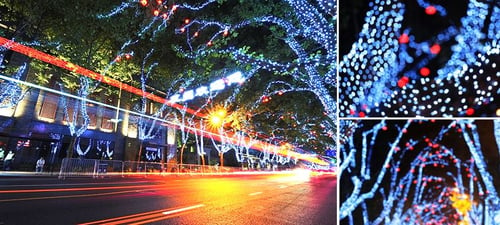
[{"left": 59, "top": 158, "right": 237, "bottom": 179}]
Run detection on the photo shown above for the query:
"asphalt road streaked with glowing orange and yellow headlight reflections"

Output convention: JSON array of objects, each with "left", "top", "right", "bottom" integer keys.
[{"left": 0, "top": 171, "right": 337, "bottom": 225}]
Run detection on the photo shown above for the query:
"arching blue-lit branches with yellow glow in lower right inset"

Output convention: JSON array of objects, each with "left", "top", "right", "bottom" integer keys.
[{"left": 339, "top": 120, "right": 500, "bottom": 224}]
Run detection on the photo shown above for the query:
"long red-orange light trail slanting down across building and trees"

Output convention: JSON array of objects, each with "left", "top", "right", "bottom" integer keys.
[{"left": 0, "top": 36, "right": 329, "bottom": 166}]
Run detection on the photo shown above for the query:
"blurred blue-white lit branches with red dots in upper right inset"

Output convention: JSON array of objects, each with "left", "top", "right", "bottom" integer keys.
[{"left": 339, "top": 0, "right": 500, "bottom": 117}]
